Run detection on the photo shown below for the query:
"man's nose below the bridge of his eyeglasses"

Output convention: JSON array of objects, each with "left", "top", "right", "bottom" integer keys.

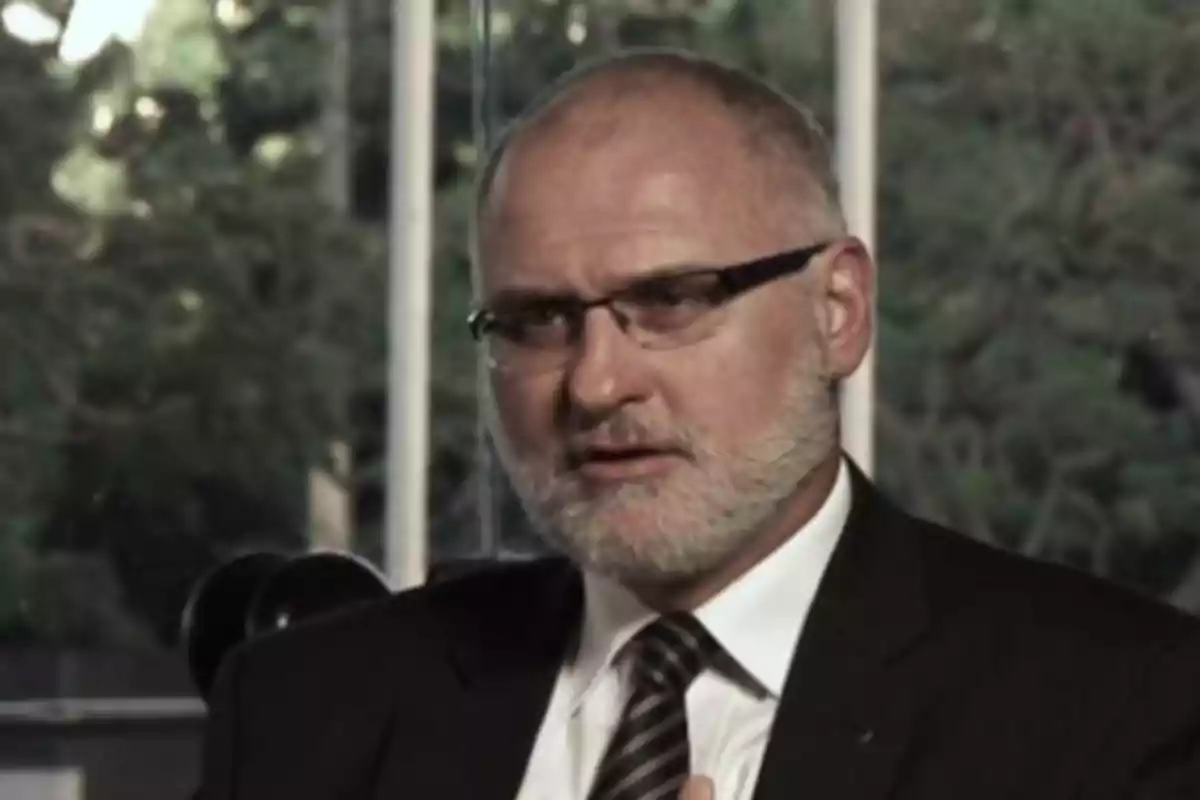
[{"left": 565, "top": 307, "right": 650, "bottom": 420}]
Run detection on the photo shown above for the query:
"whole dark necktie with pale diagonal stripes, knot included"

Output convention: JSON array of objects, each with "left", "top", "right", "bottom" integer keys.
[{"left": 588, "top": 613, "right": 720, "bottom": 800}]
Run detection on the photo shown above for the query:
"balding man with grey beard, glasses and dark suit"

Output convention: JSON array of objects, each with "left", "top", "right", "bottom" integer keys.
[{"left": 202, "top": 52, "right": 1200, "bottom": 800}]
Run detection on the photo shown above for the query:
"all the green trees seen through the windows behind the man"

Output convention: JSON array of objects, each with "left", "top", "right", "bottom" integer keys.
[{"left": 0, "top": 0, "right": 1200, "bottom": 646}]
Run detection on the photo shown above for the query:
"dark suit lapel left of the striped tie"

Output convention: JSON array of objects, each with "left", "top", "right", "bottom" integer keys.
[{"left": 374, "top": 560, "right": 582, "bottom": 800}]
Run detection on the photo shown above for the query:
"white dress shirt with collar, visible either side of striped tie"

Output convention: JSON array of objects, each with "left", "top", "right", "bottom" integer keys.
[{"left": 517, "top": 462, "right": 851, "bottom": 800}]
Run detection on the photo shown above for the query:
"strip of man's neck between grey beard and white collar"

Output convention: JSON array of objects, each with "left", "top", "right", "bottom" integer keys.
[{"left": 630, "top": 449, "right": 841, "bottom": 613}]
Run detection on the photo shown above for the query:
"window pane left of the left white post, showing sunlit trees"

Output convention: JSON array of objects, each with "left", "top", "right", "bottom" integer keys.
[{"left": 0, "top": 0, "right": 403, "bottom": 800}]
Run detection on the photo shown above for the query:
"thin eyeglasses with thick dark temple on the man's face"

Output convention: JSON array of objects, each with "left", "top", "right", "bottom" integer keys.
[{"left": 467, "top": 242, "right": 830, "bottom": 373}]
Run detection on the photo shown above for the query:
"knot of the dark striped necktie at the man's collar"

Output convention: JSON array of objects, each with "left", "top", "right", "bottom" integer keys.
[{"left": 632, "top": 612, "right": 720, "bottom": 694}]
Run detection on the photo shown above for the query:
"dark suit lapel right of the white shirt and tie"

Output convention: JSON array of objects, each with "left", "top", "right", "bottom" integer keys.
[{"left": 754, "top": 468, "right": 928, "bottom": 800}]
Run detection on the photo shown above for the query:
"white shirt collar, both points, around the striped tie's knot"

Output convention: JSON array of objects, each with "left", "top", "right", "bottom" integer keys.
[{"left": 566, "top": 459, "right": 851, "bottom": 712}]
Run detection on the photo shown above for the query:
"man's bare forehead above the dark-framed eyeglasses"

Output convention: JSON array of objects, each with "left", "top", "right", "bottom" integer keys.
[{"left": 476, "top": 79, "right": 830, "bottom": 290}]
